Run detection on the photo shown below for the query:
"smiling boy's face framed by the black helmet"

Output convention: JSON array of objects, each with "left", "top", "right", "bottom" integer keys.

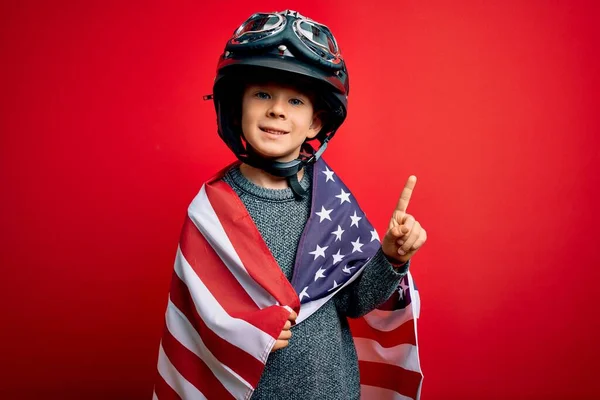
[{"left": 242, "top": 83, "right": 322, "bottom": 162}]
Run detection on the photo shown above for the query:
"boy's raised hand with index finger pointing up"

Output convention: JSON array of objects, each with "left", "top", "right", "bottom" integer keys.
[{"left": 381, "top": 175, "right": 427, "bottom": 264}]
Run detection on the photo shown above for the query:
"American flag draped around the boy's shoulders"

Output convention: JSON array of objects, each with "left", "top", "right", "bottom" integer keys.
[{"left": 153, "top": 159, "right": 423, "bottom": 400}]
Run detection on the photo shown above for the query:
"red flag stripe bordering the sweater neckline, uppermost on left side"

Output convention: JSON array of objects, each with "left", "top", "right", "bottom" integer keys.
[{"left": 205, "top": 181, "right": 300, "bottom": 312}]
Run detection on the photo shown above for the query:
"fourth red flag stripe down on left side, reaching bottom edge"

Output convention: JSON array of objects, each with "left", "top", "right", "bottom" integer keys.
[{"left": 162, "top": 329, "right": 235, "bottom": 399}]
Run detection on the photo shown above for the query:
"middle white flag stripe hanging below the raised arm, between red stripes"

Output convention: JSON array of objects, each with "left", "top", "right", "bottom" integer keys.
[{"left": 354, "top": 337, "right": 421, "bottom": 372}]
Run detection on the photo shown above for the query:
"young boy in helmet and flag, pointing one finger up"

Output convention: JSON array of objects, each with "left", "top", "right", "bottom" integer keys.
[{"left": 154, "top": 10, "right": 426, "bottom": 399}]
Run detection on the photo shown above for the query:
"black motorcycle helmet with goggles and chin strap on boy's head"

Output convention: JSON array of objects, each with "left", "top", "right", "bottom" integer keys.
[{"left": 213, "top": 10, "right": 350, "bottom": 197}]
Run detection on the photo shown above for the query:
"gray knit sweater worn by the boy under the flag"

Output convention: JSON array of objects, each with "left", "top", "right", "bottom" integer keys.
[{"left": 223, "top": 166, "right": 408, "bottom": 400}]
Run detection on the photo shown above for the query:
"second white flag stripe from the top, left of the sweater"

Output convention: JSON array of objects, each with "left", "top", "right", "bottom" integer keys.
[{"left": 175, "top": 248, "right": 275, "bottom": 364}]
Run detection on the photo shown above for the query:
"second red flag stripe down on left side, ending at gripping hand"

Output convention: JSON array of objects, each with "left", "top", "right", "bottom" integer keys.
[{"left": 179, "top": 218, "right": 289, "bottom": 339}]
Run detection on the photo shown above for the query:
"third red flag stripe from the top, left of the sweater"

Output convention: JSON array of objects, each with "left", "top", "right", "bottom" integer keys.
[{"left": 170, "top": 273, "right": 264, "bottom": 387}]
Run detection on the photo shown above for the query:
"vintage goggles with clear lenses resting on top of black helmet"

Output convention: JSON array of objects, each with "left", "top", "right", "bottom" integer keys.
[{"left": 225, "top": 10, "right": 344, "bottom": 70}]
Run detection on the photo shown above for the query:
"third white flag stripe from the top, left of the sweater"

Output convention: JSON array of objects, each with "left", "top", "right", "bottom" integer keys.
[{"left": 166, "top": 300, "right": 252, "bottom": 398}]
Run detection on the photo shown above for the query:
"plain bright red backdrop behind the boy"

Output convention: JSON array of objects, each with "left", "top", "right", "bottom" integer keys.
[{"left": 0, "top": 0, "right": 600, "bottom": 400}]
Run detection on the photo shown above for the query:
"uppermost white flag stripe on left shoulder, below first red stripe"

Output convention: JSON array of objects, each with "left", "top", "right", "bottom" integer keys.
[{"left": 188, "top": 185, "right": 279, "bottom": 309}]
